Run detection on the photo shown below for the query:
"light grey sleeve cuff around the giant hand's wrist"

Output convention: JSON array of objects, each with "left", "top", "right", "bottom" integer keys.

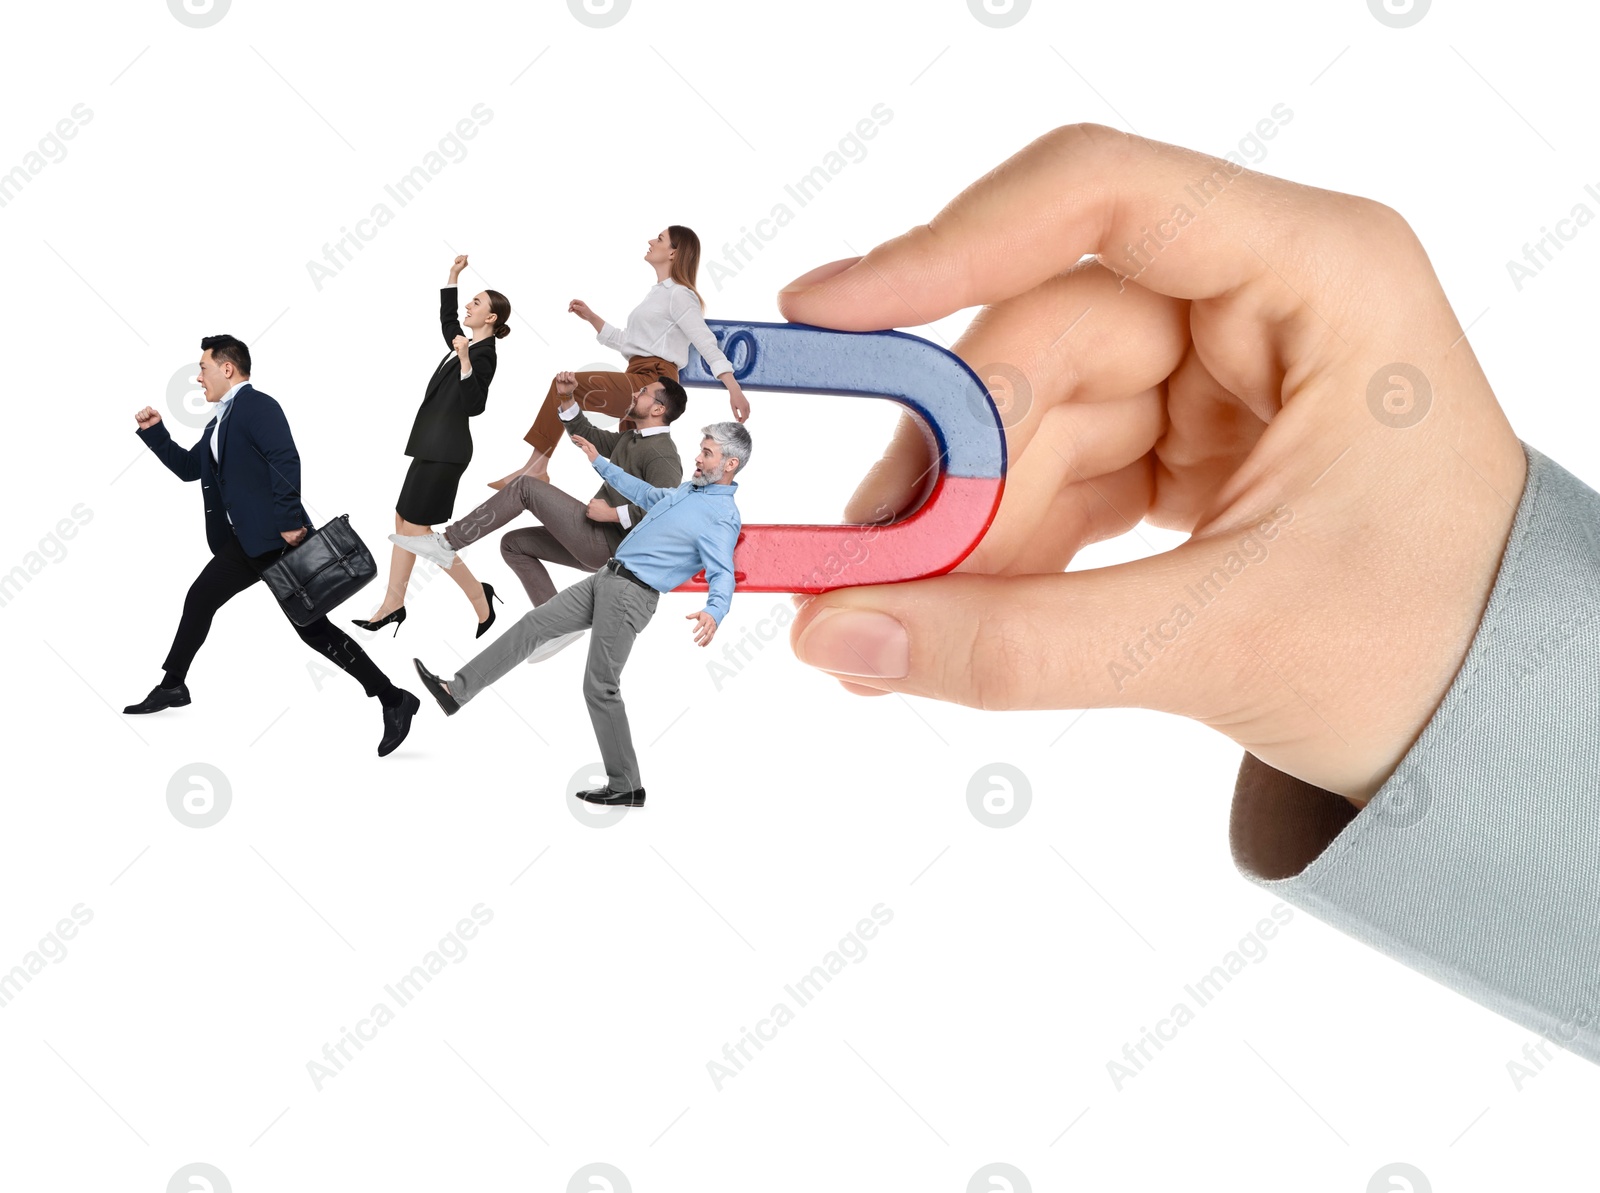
[{"left": 1229, "top": 443, "right": 1600, "bottom": 1063}]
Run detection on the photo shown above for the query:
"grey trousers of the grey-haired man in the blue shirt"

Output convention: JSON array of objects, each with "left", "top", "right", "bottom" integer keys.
[{"left": 450, "top": 566, "right": 661, "bottom": 792}]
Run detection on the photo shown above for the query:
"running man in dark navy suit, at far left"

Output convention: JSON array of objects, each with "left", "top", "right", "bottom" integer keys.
[{"left": 123, "top": 336, "right": 419, "bottom": 755}]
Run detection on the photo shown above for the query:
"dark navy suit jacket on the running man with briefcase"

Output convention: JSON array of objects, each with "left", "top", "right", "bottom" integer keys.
[{"left": 138, "top": 385, "right": 310, "bottom": 555}]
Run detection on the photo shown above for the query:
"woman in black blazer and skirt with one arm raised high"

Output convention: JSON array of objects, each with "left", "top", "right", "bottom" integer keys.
[{"left": 355, "top": 256, "right": 510, "bottom": 636}]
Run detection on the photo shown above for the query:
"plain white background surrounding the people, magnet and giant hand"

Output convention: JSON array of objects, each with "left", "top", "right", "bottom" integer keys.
[{"left": 0, "top": 0, "right": 1600, "bottom": 1193}]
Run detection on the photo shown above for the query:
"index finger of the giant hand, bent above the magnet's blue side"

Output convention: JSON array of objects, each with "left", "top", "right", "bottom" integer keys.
[{"left": 778, "top": 125, "right": 1381, "bottom": 331}]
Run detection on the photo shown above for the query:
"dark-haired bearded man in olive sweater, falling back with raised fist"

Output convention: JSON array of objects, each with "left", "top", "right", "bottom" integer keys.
[{"left": 389, "top": 373, "right": 688, "bottom": 662}]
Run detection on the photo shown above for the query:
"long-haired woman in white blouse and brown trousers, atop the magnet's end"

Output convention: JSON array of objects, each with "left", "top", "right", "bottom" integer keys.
[{"left": 490, "top": 224, "right": 750, "bottom": 489}]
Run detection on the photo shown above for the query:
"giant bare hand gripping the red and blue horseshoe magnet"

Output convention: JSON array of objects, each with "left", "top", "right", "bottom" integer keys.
[{"left": 778, "top": 125, "right": 1526, "bottom": 804}]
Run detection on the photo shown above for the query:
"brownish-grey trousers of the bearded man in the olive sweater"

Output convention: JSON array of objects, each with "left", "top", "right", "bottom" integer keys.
[{"left": 445, "top": 477, "right": 614, "bottom": 606}]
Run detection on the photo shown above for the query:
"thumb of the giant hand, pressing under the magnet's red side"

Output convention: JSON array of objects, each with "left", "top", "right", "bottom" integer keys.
[{"left": 789, "top": 521, "right": 1293, "bottom": 723}]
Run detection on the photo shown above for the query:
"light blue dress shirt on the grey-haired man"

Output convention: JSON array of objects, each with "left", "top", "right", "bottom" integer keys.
[{"left": 594, "top": 456, "right": 741, "bottom": 625}]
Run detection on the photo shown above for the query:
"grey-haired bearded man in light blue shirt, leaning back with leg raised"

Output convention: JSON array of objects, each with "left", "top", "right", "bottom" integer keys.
[{"left": 413, "top": 422, "right": 750, "bottom": 808}]
